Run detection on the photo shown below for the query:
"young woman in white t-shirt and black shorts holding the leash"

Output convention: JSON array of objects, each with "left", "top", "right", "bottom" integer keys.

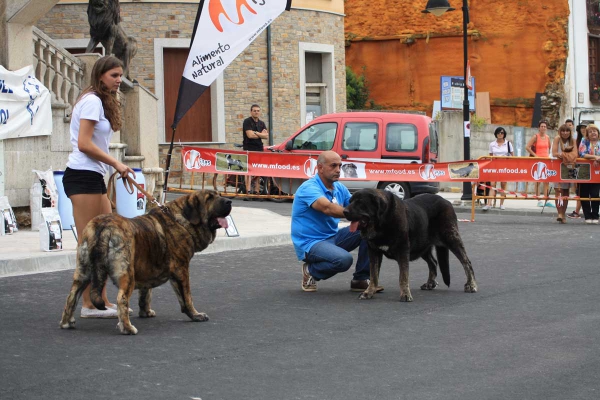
[{"left": 63, "top": 56, "right": 135, "bottom": 318}]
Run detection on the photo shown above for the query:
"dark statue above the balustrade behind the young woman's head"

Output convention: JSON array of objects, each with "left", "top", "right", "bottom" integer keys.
[{"left": 86, "top": 0, "right": 137, "bottom": 78}]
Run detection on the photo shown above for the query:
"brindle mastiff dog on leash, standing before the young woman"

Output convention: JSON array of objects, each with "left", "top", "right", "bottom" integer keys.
[{"left": 60, "top": 190, "right": 231, "bottom": 335}]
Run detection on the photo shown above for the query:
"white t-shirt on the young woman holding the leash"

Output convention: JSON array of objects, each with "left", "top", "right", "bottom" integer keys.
[{"left": 67, "top": 93, "right": 113, "bottom": 175}]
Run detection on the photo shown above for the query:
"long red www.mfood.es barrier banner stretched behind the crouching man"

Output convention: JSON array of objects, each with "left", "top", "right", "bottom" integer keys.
[{"left": 181, "top": 146, "right": 600, "bottom": 183}]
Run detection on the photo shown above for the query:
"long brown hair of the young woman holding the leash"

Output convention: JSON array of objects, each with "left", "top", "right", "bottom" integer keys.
[{"left": 77, "top": 56, "right": 123, "bottom": 132}]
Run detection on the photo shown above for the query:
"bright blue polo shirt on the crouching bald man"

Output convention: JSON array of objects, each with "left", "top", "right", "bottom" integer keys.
[{"left": 292, "top": 175, "right": 351, "bottom": 261}]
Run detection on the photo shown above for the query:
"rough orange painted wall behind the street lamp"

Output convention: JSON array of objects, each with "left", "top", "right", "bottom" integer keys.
[{"left": 345, "top": 0, "right": 569, "bottom": 126}]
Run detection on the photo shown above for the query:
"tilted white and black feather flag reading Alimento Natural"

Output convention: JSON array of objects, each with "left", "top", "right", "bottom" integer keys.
[{"left": 171, "top": 0, "right": 291, "bottom": 128}]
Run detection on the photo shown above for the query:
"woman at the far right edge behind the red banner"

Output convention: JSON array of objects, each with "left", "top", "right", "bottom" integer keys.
[{"left": 579, "top": 124, "right": 600, "bottom": 224}]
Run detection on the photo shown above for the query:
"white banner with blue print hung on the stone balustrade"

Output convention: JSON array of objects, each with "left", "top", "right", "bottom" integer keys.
[{"left": 0, "top": 65, "right": 52, "bottom": 140}]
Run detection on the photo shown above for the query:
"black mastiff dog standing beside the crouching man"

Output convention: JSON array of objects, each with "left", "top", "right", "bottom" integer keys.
[{"left": 344, "top": 189, "right": 477, "bottom": 301}]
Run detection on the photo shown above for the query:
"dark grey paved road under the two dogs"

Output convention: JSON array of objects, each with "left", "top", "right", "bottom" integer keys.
[{"left": 0, "top": 214, "right": 600, "bottom": 400}]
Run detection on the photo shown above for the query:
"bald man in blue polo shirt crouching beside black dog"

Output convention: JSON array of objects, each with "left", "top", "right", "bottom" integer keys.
[{"left": 292, "top": 151, "right": 383, "bottom": 292}]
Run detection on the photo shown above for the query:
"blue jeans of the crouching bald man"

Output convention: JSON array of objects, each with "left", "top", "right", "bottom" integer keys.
[{"left": 304, "top": 227, "right": 370, "bottom": 281}]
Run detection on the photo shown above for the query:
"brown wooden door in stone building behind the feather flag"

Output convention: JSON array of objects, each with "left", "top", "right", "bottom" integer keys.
[{"left": 163, "top": 48, "right": 213, "bottom": 143}]
